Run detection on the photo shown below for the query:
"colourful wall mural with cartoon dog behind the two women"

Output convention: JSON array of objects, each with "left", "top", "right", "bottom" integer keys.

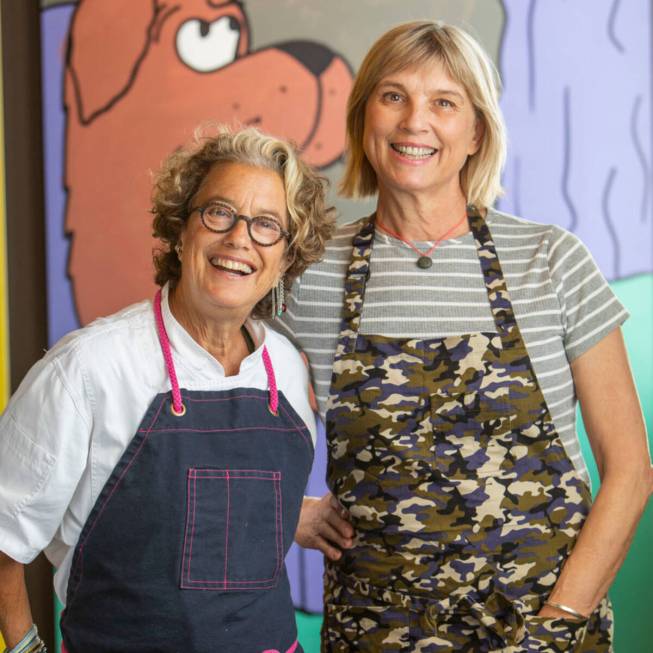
[{"left": 42, "top": 0, "right": 653, "bottom": 651}]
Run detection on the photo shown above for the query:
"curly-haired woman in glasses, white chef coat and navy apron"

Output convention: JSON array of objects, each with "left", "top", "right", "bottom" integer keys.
[{"left": 0, "top": 128, "right": 332, "bottom": 653}]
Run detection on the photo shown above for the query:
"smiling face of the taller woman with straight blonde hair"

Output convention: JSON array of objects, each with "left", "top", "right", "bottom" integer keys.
[{"left": 363, "top": 60, "right": 481, "bottom": 201}]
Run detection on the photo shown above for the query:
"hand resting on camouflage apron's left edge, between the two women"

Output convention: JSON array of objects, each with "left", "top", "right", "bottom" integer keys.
[{"left": 295, "top": 492, "right": 354, "bottom": 560}]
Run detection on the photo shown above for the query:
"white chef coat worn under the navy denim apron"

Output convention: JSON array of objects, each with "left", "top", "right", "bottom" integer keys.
[{"left": 0, "top": 287, "right": 316, "bottom": 603}]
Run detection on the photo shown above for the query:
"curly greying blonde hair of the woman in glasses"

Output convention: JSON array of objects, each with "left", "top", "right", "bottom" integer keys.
[{"left": 152, "top": 125, "right": 335, "bottom": 317}]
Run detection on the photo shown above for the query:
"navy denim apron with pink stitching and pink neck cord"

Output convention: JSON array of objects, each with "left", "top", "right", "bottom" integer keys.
[{"left": 61, "top": 292, "right": 313, "bottom": 653}]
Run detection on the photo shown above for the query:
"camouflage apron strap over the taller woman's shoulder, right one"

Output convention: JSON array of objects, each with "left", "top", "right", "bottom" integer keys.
[{"left": 467, "top": 206, "right": 521, "bottom": 348}]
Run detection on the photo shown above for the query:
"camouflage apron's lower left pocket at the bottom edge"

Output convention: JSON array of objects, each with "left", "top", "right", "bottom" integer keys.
[{"left": 322, "top": 603, "right": 410, "bottom": 653}]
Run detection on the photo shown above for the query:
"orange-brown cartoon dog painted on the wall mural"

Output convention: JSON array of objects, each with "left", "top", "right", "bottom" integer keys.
[{"left": 65, "top": 0, "right": 352, "bottom": 324}]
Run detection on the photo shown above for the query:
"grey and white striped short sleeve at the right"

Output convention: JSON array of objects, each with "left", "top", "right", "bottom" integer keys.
[{"left": 548, "top": 227, "right": 628, "bottom": 362}]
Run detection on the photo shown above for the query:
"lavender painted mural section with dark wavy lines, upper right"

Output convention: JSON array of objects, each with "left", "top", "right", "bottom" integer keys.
[{"left": 500, "top": 0, "right": 653, "bottom": 280}]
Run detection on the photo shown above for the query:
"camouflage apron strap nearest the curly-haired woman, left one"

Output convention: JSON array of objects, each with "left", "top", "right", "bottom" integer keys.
[{"left": 336, "top": 214, "right": 374, "bottom": 360}]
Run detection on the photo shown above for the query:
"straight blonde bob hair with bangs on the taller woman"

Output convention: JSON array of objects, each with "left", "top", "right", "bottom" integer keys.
[{"left": 340, "top": 20, "right": 506, "bottom": 208}]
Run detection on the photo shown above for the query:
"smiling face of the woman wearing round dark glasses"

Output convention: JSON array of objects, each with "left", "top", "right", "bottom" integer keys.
[{"left": 175, "top": 163, "right": 288, "bottom": 322}]
